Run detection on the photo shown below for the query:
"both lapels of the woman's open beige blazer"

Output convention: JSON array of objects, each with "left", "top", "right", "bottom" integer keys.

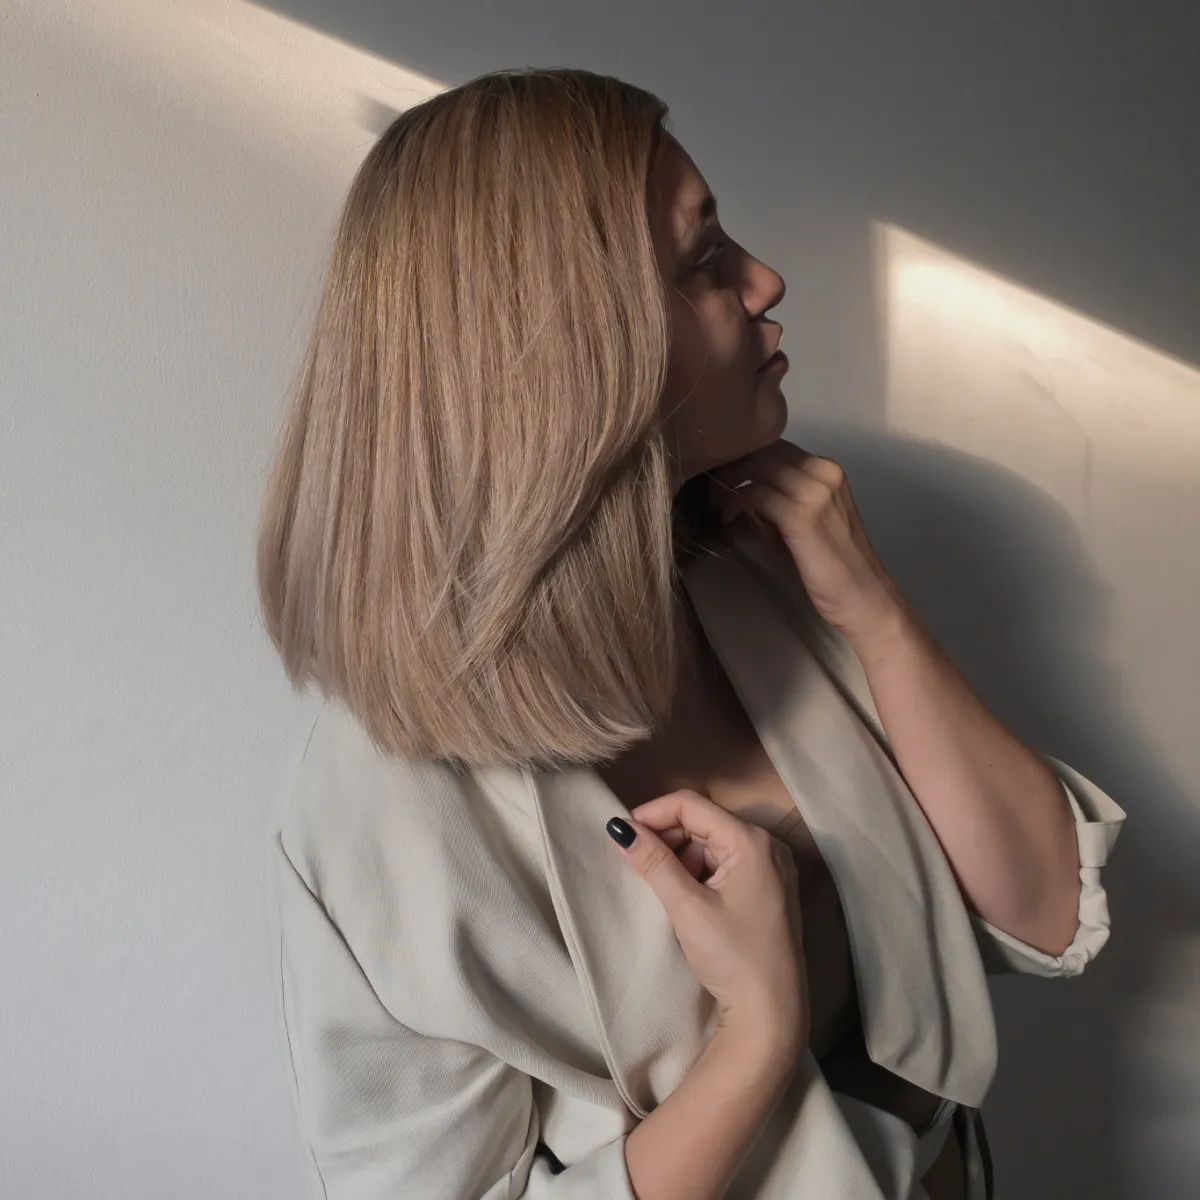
[{"left": 528, "top": 535, "right": 996, "bottom": 1117}]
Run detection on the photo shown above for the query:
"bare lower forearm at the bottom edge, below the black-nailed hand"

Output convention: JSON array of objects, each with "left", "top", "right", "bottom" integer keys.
[{"left": 625, "top": 1028, "right": 800, "bottom": 1200}]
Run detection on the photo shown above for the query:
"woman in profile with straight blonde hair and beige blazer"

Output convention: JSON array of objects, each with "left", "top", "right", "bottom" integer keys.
[{"left": 259, "top": 70, "right": 1123, "bottom": 1200}]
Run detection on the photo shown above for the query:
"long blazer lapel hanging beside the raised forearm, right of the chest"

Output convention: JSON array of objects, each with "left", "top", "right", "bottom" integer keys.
[{"left": 688, "top": 540, "right": 996, "bottom": 1106}]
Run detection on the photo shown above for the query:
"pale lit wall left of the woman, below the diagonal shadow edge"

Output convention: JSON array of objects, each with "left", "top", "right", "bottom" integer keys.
[{"left": 0, "top": 0, "right": 441, "bottom": 1200}]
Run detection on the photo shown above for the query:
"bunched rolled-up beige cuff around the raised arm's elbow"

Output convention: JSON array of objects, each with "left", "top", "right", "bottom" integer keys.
[{"left": 971, "top": 755, "right": 1126, "bottom": 977}]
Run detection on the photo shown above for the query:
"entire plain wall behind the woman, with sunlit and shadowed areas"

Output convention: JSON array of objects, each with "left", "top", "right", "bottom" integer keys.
[{"left": 0, "top": 0, "right": 1200, "bottom": 1200}]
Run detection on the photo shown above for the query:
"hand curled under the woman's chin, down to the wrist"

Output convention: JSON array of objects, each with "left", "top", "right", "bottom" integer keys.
[{"left": 709, "top": 438, "right": 902, "bottom": 638}]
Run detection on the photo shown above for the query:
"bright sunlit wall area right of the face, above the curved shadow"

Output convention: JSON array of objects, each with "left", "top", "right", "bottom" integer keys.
[{"left": 872, "top": 224, "right": 1200, "bottom": 832}]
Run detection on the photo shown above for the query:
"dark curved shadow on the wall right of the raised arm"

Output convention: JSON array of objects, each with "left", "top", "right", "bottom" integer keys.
[{"left": 803, "top": 424, "right": 1200, "bottom": 1200}]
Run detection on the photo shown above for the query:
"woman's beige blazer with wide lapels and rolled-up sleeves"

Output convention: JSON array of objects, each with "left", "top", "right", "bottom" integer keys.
[{"left": 266, "top": 535, "right": 1124, "bottom": 1200}]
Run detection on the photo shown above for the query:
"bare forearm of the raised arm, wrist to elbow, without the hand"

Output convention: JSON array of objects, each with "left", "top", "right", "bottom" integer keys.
[{"left": 850, "top": 598, "right": 1079, "bottom": 955}]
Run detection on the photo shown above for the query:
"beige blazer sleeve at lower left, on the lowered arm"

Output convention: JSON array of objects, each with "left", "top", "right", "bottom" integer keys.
[{"left": 268, "top": 838, "right": 636, "bottom": 1200}]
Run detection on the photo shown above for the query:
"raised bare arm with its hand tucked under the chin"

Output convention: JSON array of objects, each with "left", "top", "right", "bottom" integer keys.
[{"left": 712, "top": 438, "right": 1081, "bottom": 955}]
